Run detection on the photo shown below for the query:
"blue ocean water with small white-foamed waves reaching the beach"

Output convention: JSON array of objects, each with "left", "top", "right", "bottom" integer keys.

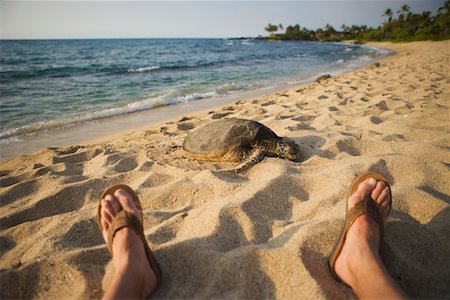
[{"left": 0, "top": 39, "right": 390, "bottom": 145}]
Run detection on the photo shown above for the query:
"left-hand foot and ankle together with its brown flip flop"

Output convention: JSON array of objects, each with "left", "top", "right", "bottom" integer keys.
[{"left": 99, "top": 186, "right": 160, "bottom": 298}]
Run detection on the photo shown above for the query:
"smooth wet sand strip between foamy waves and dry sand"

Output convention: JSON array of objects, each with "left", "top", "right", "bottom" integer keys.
[{"left": 0, "top": 43, "right": 396, "bottom": 161}]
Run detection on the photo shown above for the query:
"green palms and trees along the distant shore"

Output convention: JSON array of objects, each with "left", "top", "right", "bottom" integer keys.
[{"left": 265, "top": 0, "right": 450, "bottom": 42}]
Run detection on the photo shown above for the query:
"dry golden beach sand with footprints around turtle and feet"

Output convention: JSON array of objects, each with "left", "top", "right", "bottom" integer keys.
[{"left": 0, "top": 41, "right": 450, "bottom": 299}]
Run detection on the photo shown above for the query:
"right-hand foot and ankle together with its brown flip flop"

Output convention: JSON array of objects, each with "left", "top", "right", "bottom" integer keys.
[{"left": 330, "top": 173, "right": 407, "bottom": 299}]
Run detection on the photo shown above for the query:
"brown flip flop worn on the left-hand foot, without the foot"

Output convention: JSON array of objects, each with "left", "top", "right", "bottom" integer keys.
[{"left": 97, "top": 184, "right": 162, "bottom": 287}]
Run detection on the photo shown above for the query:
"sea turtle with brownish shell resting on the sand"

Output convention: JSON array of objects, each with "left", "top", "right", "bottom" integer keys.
[{"left": 183, "top": 118, "right": 300, "bottom": 172}]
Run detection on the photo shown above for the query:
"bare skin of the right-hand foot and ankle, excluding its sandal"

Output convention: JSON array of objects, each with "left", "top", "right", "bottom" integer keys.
[{"left": 335, "top": 178, "right": 406, "bottom": 299}]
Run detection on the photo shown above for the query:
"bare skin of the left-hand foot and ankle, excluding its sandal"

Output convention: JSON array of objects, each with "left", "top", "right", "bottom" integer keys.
[{"left": 100, "top": 189, "right": 157, "bottom": 299}]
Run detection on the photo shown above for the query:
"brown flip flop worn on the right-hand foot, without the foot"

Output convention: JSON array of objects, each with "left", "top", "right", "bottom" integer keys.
[{"left": 328, "top": 172, "right": 392, "bottom": 282}]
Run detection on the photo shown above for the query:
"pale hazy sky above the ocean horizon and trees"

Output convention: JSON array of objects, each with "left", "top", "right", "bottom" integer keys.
[{"left": 0, "top": 0, "right": 445, "bottom": 39}]
